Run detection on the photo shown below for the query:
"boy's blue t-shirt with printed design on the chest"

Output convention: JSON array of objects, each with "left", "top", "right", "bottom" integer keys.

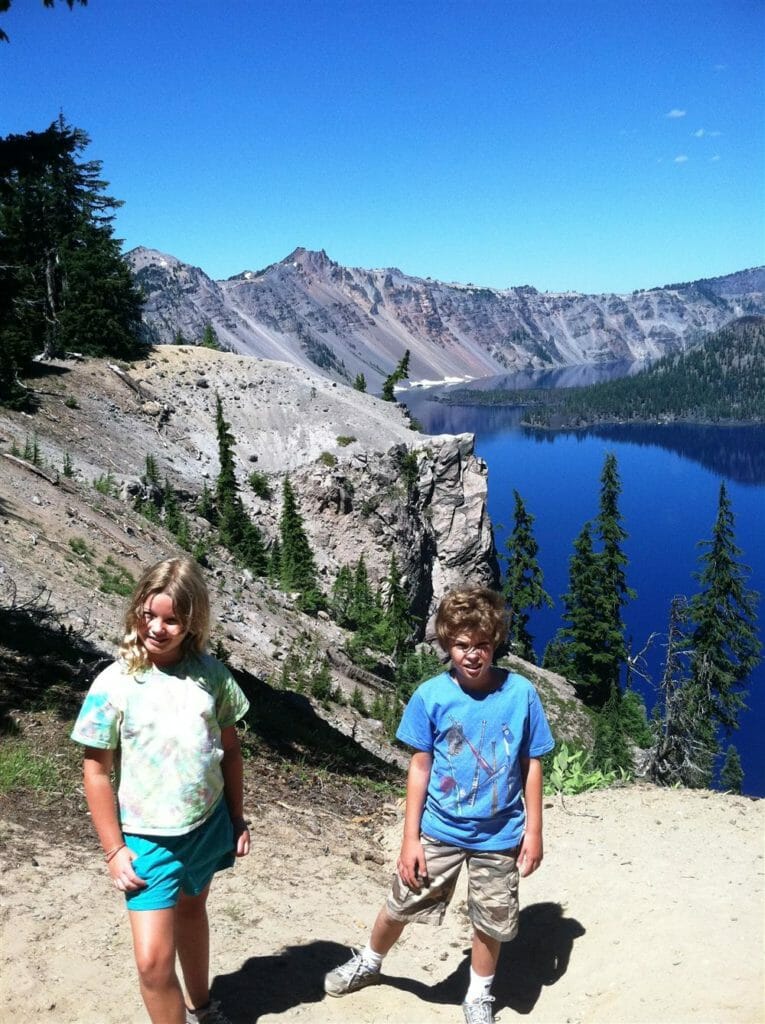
[{"left": 396, "top": 672, "right": 554, "bottom": 850}]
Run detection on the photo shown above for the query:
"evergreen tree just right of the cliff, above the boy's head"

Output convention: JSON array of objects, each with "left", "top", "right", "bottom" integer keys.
[{"left": 502, "top": 490, "right": 552, "bottom": 663}]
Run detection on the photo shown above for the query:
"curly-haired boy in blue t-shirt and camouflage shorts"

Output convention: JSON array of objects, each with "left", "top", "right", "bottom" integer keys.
[{"left": 325, "top": 587, "right": 554, "bottom": 1024}]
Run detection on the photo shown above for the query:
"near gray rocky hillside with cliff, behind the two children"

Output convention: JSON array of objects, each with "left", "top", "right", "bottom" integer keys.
[{"left": 0, "top": 346, "right": 586, "bottom": 754}]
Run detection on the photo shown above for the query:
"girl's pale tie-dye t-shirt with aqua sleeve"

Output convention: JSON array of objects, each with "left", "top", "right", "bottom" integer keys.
[{"left": 72, "top": 654, "right": 249, "bottom": 836}]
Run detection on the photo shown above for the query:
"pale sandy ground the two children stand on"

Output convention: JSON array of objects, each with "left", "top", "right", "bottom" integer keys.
[{"left": 0, "top": 786, "right": 765, "bottom": 1024}]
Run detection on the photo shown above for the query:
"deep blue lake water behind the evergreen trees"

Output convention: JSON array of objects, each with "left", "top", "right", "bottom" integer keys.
[{"left": 400, "top": 370, "right": 765, "bottom": 797}]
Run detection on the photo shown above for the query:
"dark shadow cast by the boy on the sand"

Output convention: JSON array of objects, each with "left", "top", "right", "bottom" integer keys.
[{"left": 384, "top": 902, "right": 585, "bottom": 1014}]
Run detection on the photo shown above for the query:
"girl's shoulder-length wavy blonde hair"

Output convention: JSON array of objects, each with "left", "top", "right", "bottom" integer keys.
[{"left": 120, "top": 558, "right": 210, "bottom": 674}]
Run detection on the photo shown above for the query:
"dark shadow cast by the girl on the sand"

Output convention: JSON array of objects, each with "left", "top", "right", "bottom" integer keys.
[{"left": 212, "top": 940, "right": 348, "bottom": 1024}]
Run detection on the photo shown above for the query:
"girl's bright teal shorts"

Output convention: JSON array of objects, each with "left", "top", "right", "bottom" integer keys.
[{"left": 125, "top": 800, "right": 236, "bottom": 910}]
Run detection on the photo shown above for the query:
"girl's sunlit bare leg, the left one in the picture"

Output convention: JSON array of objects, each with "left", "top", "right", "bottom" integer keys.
[{"left": 130, "top": 907, "right": 185, "bottom": 1024}]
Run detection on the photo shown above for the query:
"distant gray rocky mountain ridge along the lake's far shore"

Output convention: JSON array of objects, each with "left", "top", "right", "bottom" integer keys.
[{"left": 128, "top": 248, "right": 765, "bottom": 390}]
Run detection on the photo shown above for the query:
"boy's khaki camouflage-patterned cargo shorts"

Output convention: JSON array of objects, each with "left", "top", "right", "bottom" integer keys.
[{"left": 385, "top": 836, "right": 518, "bottom": 942}]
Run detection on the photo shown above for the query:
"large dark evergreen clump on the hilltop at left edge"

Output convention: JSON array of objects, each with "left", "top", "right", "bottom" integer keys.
[{"left": 0, "top": 117, "right": 141, "bottom": 400}]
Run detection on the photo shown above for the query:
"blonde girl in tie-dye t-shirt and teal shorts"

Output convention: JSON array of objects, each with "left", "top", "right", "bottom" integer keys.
[{"left": 72, "top": 558, "right": 250, "bottom": 1024}]
